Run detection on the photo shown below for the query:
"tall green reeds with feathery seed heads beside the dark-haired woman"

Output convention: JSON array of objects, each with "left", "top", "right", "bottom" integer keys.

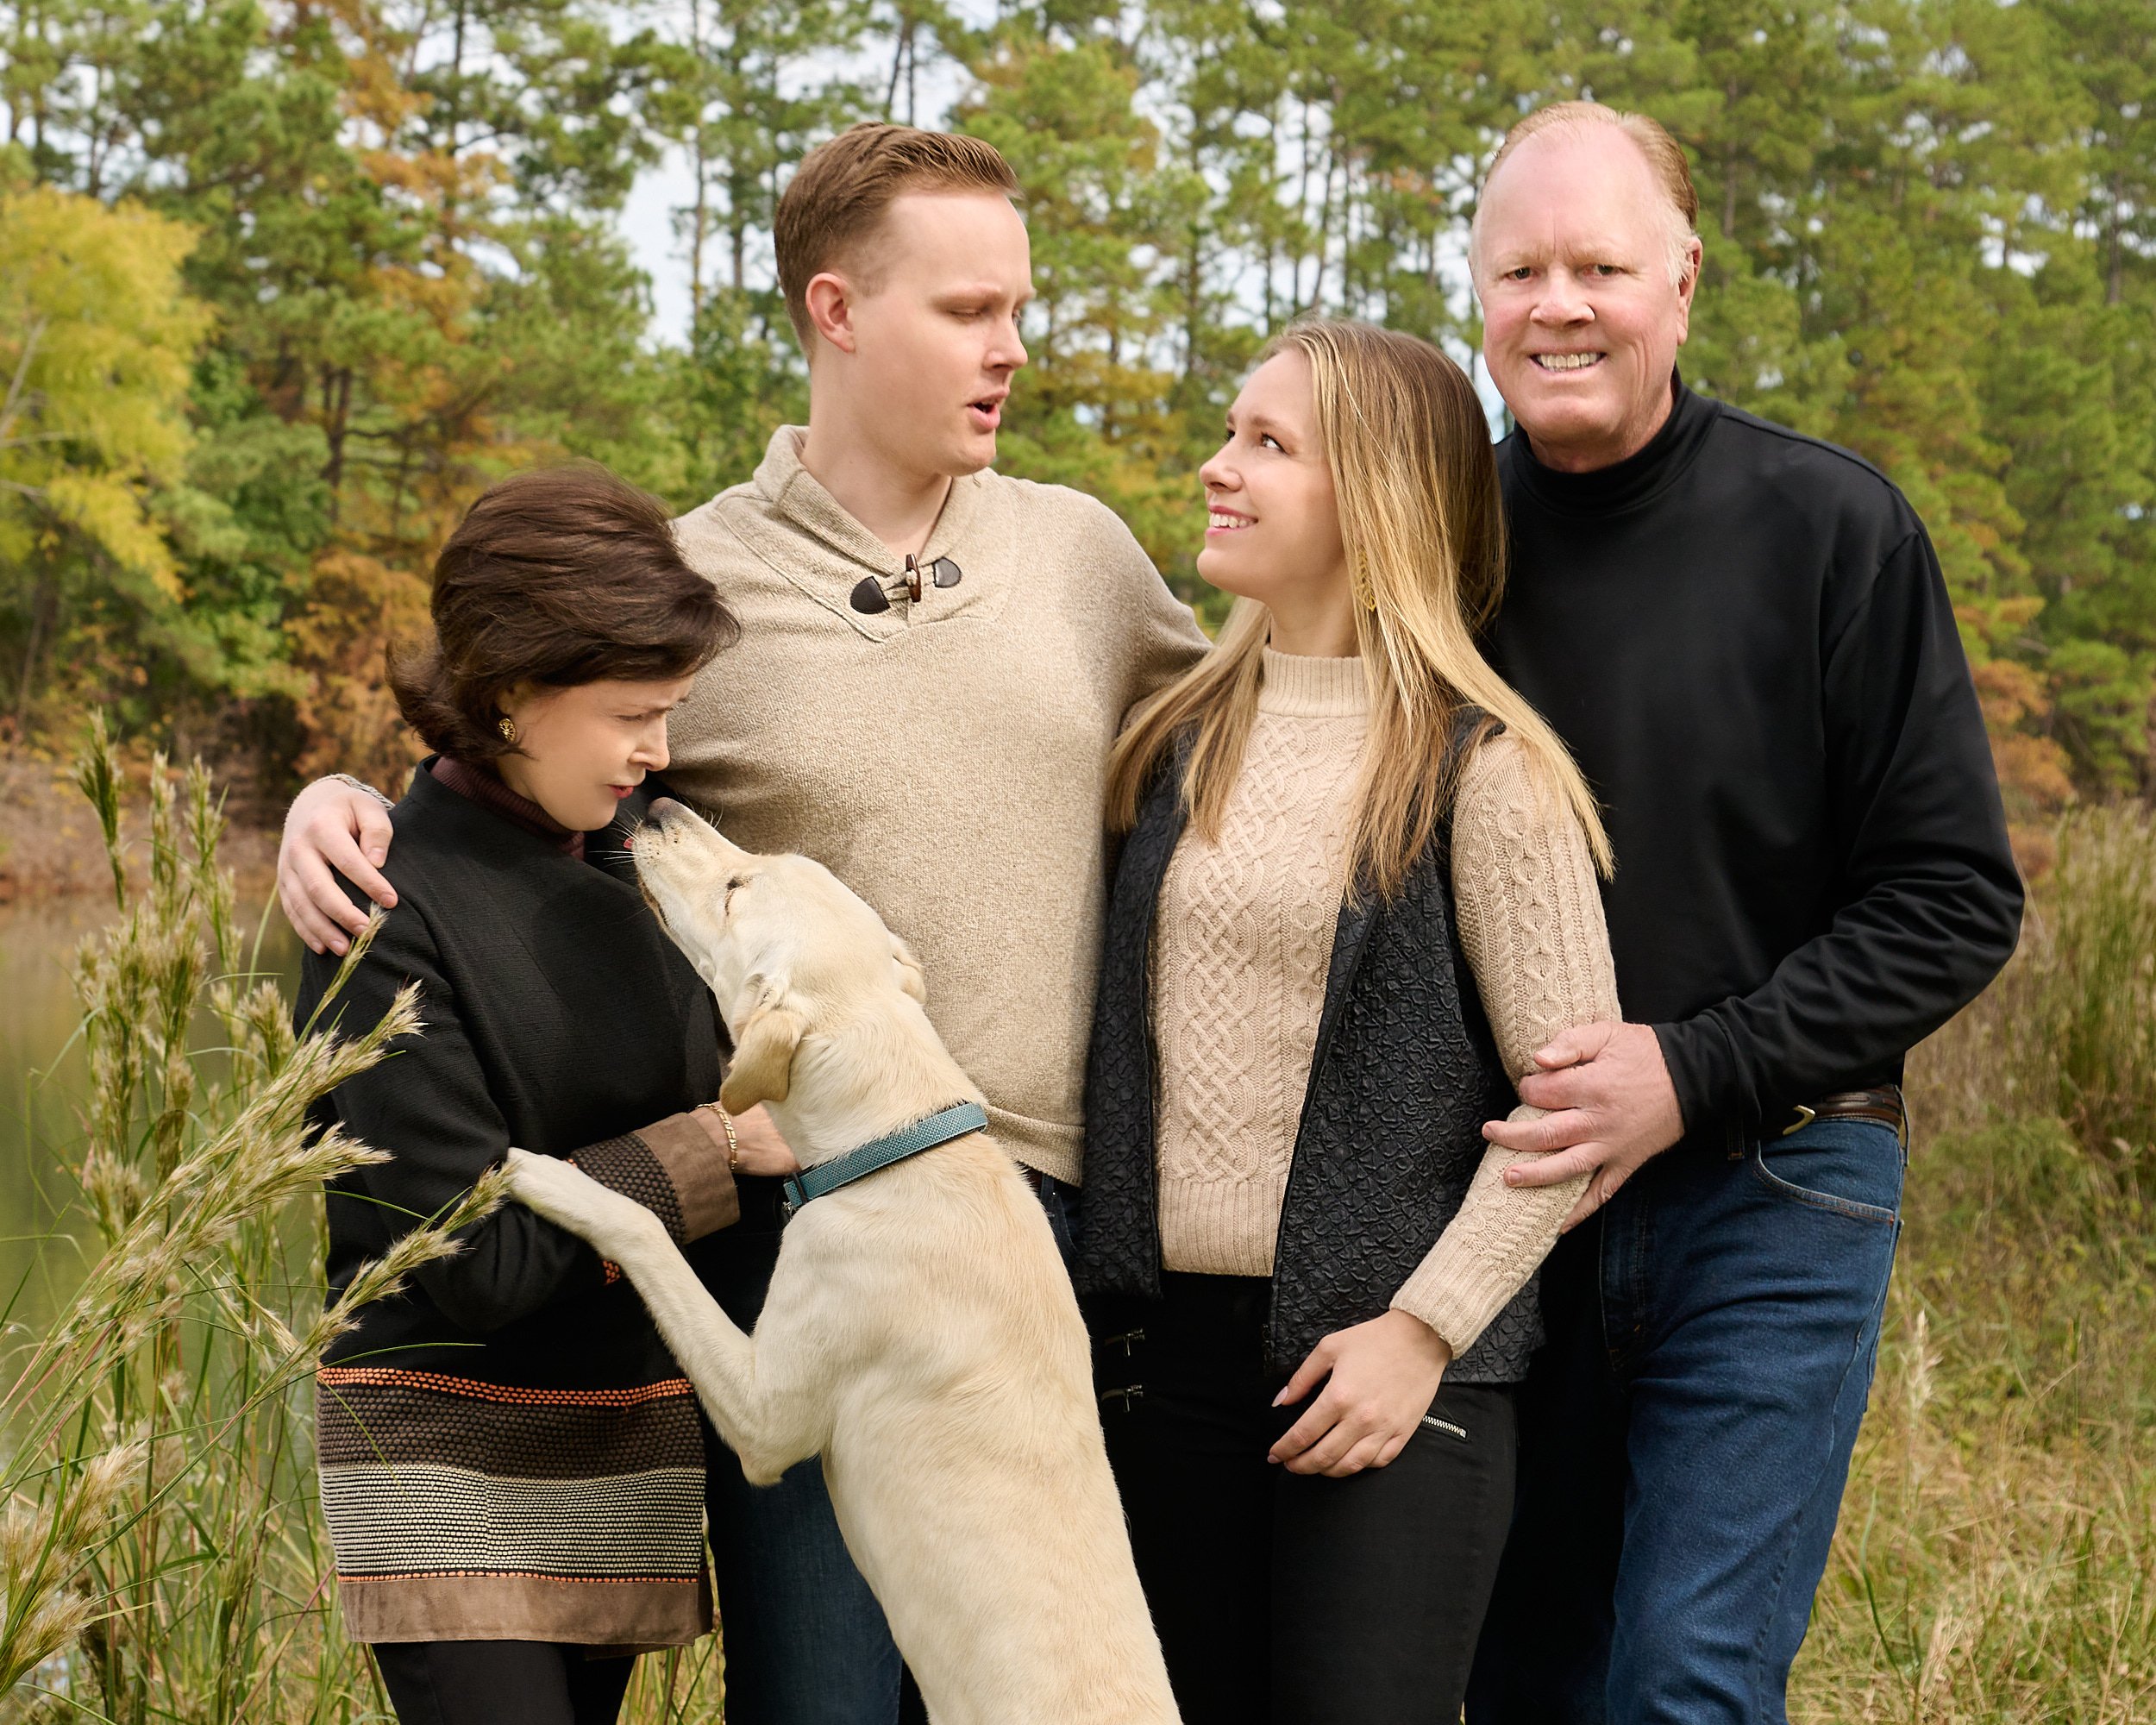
[{"left": 0, "top": 724, "right": 500, "bottom": 1725}]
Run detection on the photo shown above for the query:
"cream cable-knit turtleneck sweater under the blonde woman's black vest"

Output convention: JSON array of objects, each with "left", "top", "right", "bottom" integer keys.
[{"left": 1154, "top": 651, "right": 1620, "bottom": 1357}]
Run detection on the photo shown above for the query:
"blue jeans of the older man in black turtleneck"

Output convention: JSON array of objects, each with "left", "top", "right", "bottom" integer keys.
[{"left": 1466, "top": 1120, "right": 1906, "bottom": 1725}]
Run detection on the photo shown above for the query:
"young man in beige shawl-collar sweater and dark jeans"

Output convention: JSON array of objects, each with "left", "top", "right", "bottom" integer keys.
[{"left": 279, "top": 125, "right": 1206, "bottom": 1725}]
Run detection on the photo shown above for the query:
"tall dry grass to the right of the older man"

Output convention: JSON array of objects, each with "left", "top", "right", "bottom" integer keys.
[{"left": 1792, "top": 811, "right": 2156, "bottom": 1725}]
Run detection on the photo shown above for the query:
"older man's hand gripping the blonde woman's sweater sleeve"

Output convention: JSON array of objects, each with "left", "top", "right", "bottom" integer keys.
[{"left": 1483, "top": 1025, "right": 1684, "bottom": 1229}]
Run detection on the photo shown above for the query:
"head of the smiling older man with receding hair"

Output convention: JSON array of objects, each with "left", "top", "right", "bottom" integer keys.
[{"left": 1470, "top": 102, "right": 1699, "bottom": 473}]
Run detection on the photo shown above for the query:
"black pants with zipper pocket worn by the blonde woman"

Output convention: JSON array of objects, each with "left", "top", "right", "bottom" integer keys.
[{"left": 1087, "top": 1275, "right": 1514, "bottom": 1725}]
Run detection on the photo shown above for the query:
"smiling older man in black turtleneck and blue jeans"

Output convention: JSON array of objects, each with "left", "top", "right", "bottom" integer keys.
[{"left": 1469, "top": 104, "right": 2022, "bottom": 1725}]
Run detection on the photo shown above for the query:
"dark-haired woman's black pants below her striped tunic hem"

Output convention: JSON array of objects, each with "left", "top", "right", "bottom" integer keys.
[{"left": 373, "top": 1641, "right": 636, "bottom": 1725}]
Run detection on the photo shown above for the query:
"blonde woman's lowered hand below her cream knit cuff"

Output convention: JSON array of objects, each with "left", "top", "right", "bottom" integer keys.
[{"left": 1266, "top": 1311, "right": 1453, "bottom": 1479}]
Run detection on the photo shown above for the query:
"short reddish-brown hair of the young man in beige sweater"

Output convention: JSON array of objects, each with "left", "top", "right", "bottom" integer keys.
[{"left": 772, "top": 121, "right": 1018, "bottom": 352}]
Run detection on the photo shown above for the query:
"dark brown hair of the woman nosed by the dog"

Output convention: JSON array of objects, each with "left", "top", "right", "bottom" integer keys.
[{"left": 391, "top": 461, "right": 740, "bottom": 762}]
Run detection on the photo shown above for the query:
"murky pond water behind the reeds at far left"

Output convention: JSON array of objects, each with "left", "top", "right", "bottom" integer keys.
[{"left": 0, "top": 893, "right": 300, "bottom": 1331}]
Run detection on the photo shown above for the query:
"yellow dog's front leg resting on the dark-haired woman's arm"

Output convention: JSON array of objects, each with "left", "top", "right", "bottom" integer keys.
[{"left": 509, "top": 1150, "right": 828, "bottom": 1484}]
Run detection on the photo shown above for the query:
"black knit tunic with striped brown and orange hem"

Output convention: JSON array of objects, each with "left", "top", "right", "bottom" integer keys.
[{"left": 298, "top": 770, "right": 740, "bottom": 1647}]
